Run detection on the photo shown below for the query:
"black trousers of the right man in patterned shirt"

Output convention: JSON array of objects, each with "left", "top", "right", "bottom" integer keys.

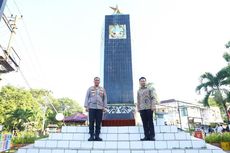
[{"left": 140, "top": 109, "right": 155, "bottom": 138}]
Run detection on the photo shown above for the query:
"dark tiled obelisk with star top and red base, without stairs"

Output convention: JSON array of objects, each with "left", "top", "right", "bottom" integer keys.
[{"left": 103, "top": 7, "right": 135, "bottom": 126}]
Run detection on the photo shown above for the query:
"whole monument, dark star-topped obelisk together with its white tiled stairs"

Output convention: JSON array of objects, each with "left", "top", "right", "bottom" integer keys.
[{"left": 18, "top": 5, "right": 224, "bottom": 153}]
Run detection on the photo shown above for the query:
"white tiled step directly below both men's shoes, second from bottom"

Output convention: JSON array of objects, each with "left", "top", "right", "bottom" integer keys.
[{"left": 34, "top": 139, "right": 206, "bottom": 150}]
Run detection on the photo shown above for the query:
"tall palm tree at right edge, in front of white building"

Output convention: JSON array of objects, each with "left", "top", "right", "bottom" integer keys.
[{"left": 196, "top": 66, "right": 230, "bottom": 123}]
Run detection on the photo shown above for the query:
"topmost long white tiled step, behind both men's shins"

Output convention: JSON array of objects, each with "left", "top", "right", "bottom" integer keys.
[{"left": 61, "top": 125, "right": 178, "bottom": 133}]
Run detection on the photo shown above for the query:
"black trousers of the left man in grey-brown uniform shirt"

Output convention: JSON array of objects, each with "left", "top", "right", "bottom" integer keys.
[{"left": 89, "top": 109, "right": 103, "bottom": 136}]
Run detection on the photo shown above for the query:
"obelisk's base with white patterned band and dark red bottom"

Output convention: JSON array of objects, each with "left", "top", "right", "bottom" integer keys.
[{"left": 102, "top": 105, "right": 136, "bottom": 126}]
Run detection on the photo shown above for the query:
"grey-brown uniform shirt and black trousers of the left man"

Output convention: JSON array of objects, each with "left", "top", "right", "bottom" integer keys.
[{"left": 84, "top": 86, "right": 107, "bottom": 139}]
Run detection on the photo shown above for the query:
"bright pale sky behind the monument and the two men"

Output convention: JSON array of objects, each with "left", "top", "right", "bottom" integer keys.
[{"left": 0, "top": 0, "right": 230, "bottom": 104}]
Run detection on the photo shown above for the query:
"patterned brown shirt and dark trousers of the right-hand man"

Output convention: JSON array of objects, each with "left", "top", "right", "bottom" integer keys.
[{"left": 137, "top": 87, "right": 156, "bottom": 140}]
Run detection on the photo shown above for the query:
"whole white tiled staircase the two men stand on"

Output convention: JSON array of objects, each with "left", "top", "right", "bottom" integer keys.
[{"left": 18, "top": 124, "right": 224, "bottom": 153}]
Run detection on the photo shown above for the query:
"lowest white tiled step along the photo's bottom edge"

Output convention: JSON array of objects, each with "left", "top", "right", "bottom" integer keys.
[{"left": 17, "top": 147, "right": 225, "bottom": 153}]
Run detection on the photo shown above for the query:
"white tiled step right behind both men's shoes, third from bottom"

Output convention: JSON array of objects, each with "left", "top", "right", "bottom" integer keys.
[{"left": 49, "top": 132, "right": 191, "bottom": 141}]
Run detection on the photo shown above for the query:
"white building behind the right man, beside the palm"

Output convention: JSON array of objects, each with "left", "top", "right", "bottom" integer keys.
[{"left": 157, "top": 99, "right": 223, "bottom": 129}]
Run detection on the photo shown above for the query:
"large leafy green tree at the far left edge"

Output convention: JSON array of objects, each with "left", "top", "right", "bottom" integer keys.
[{"left": 0, "top": 86, "right": 41, "bottom": 131}]
